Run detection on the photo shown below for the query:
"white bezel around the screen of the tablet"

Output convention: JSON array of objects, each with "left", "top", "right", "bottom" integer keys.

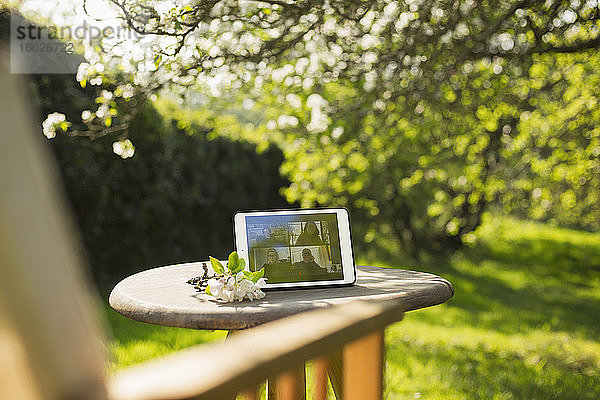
[{"left": 233, "top": 208, "right": 356, "bottom": 289}]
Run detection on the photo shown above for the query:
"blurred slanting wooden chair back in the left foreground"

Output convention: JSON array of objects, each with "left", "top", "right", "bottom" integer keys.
[{"left": 0, "top": 54, "right": 104, "bottom": 399}]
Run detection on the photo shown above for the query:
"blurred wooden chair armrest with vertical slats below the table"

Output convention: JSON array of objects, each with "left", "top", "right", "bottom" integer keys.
[{"left": 108, "top": 301, "right": 403, "bottom": 400}]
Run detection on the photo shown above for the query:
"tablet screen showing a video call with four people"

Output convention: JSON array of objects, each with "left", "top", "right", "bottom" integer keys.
[{"left": 246, "top": 213, "right": 343, "bottom": 284}]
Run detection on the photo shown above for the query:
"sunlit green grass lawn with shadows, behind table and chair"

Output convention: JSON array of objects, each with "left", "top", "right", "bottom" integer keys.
[{"left": 107, "top": 219, "right": 600, "bottom": 400}]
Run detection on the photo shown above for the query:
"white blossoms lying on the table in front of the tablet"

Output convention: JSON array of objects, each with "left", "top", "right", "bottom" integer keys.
[{"left": 207, "top": 272, "right": 266, "bottom": 302}]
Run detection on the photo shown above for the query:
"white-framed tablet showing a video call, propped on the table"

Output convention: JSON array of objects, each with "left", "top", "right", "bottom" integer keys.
[{"left": 234, "top": 208, "right": 356, "bottom": 289}]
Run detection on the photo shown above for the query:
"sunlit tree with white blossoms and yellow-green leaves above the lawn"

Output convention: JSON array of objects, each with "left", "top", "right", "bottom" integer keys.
[{"left": 63, "top": 0, "right": 600, "bottom": 257}]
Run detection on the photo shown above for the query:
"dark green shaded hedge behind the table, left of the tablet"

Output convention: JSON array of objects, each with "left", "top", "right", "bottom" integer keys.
[{"left": 32, "top": 75, "right": 290, "bottom": 288}]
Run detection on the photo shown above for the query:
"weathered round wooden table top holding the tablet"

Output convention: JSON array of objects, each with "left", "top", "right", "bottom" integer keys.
[{"left": 109, "top": 262, "right": 454, "bottom": 330}]
